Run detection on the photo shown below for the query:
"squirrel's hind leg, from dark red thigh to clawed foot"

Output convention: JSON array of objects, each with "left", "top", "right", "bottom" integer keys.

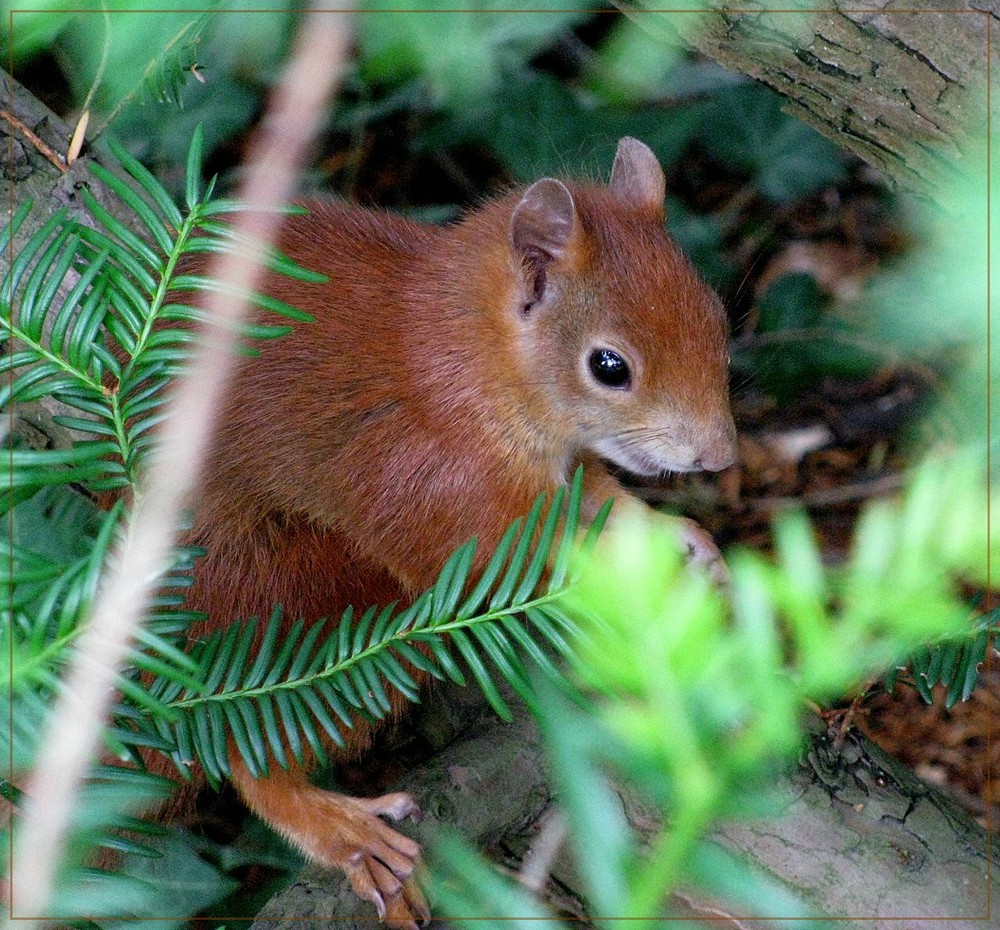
[{"left": 188, "top": 511, "right": 428, "bottom": 930}]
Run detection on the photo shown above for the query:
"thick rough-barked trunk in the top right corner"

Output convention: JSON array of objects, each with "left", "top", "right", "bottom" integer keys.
[{"left": 616, "top": 0, "right": 1000, "bottom": 193}]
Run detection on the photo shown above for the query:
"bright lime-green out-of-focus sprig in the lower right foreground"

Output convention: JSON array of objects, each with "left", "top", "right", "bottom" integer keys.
[{"left": 577, "top": 461, "right": 987, "bottom": 904}]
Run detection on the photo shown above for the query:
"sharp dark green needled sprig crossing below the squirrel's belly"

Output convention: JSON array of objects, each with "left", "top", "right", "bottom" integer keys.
[{"left": 139, "top": 471, "right": 607, "bottom": 782}]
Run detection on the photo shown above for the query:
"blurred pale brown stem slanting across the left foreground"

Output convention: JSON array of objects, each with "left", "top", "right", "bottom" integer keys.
[{"left": 11, "top": 5, "right": 348, "bottom": 930}]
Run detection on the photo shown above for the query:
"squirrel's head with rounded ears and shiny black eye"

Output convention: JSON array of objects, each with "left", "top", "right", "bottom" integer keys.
[{"left": 507, "top": 137, "right": 736, "bottom": 476}]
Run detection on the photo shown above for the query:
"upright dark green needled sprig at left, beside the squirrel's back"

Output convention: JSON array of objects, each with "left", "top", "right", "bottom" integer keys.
[{"left": 0, "top": 124, "right": 315, "bottom": 501}]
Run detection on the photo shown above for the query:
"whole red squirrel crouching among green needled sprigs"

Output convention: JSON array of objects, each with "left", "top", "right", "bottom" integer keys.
[{"left": 172, "top": 138, "right": 735, "bottom": 927}]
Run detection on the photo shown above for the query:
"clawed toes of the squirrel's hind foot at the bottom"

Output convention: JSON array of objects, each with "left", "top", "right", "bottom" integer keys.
[{"left": 316, "top": 792, "right": 430, "bottom": 930}]
